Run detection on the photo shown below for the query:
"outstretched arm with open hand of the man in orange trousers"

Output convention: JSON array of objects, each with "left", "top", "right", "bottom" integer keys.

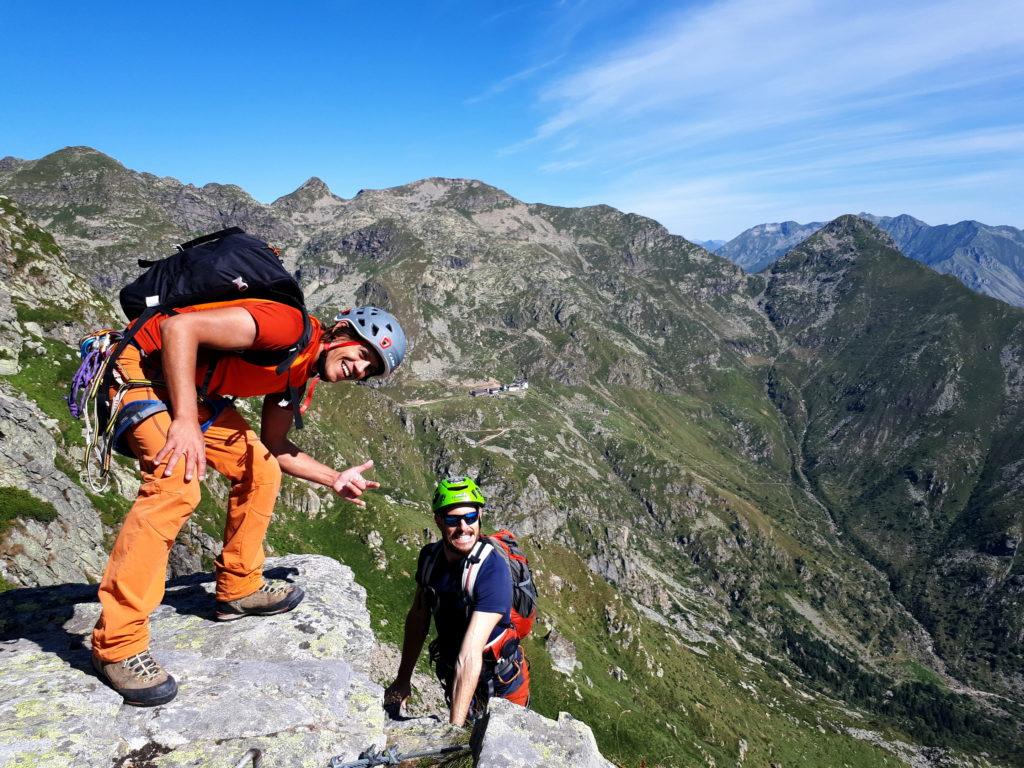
[{"left": 260, "top": 395, "right": 380, "bottom": 507}]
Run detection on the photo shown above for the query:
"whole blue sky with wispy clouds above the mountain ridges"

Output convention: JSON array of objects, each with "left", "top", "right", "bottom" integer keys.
[{"left": 0, "top": 0, "right": 1024, "bottom": 239}]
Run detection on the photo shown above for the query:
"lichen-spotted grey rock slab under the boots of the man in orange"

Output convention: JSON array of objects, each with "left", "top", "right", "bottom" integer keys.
[{"left": 0, "top": 556, "right": 385, "bottom": 768}]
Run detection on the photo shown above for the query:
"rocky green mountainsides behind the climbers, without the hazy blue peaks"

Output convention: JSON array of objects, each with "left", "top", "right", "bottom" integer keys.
[{"left": 0, "top": 147, "right": 1024, "bottom": 766}]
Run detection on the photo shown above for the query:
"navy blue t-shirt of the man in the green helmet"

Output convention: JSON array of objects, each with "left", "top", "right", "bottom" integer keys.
[{"left": 417, "top": 544, "right": 512, "bottom": 659}]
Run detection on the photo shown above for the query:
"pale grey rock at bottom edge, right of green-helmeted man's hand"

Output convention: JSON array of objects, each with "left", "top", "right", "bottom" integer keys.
[{"left": 477, "top": 698, "right": 614, "bottom": 768}]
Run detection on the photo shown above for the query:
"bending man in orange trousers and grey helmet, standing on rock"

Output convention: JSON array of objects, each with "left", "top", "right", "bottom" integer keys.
[{"left": 92, "top": 299, "right": 406, "bottom": 707}]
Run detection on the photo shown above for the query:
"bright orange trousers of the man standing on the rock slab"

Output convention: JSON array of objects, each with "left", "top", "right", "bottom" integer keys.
[{"left": 92, "top": 346, "right": 281, "bottom": 663}]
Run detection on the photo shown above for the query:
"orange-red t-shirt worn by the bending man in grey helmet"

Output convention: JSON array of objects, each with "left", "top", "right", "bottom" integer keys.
[{"left": 128, "top": 299, "right": 324, "bottom": 397}]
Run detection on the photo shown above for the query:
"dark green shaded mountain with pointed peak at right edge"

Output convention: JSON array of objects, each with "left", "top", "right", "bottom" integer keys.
[{"left": 764, "top": 217, "right": 1024, "bottom": 692}]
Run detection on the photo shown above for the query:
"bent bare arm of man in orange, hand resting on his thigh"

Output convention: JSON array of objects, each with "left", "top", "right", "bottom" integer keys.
[{"left": 155, "top": 307, "right": 256, "bottom": 481}]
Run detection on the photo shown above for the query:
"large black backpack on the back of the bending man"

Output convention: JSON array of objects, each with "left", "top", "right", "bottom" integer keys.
[{"left": 112, "top": 226, "right": 312, "bottom": 429}]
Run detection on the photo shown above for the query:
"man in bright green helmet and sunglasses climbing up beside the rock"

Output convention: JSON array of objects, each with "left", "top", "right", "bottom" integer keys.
[{"left": 384, "top": 477, "right": 529, "bottom": 725}]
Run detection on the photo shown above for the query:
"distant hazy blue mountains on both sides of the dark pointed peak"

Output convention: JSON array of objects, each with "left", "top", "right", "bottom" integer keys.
[{"left": 709, "top": 213, "right": 1024, "bottom": 306}]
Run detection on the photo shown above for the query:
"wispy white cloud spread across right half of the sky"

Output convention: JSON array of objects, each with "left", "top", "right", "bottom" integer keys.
[{"left": 524, "top": 0, "right": 1024, "bottom": 237}]
